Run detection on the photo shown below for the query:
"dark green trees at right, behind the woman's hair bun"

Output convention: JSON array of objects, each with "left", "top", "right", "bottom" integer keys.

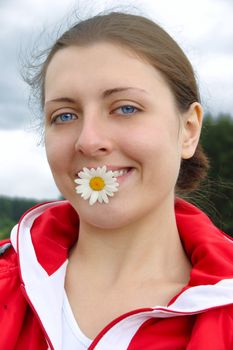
[{"left": 191, "top": 114, "right": 233, "bottom": 235}]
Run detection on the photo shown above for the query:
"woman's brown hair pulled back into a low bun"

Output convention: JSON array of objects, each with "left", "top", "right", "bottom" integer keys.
[{"left": 26, "top": 12, "right": 208, "bottom": 193}]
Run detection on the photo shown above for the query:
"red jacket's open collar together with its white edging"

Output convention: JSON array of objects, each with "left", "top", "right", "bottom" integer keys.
[{"left": 12, "top": 199, "right": 233, "bottom": 350}]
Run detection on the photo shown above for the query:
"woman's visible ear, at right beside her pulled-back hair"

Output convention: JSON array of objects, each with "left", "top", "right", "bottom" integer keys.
[{"left": 181, "top": 102, "right": 203, "bottom": 159}]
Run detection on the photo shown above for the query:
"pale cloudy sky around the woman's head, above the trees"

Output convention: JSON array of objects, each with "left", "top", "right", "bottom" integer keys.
[{"left": 0, "top": 0, "right": 233, "bottom": 199}]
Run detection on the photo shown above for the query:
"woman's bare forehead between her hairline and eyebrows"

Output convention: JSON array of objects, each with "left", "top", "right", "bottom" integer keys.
[{"left": 45, "top": 42, "right": 173, "bottom": 102}]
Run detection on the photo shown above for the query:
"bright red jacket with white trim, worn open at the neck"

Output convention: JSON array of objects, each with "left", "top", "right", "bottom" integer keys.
[{"left": 0, "top": 200, "right": 233, "bottom": 350}]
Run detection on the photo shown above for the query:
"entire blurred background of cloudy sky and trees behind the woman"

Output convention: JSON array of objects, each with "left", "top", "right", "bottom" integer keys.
[{"left": 0, "top": 0, "right": 233, "bottom": 238}]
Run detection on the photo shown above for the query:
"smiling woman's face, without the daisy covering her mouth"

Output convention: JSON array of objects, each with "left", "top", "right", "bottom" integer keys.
[{"left": 45, "top": 43, "right": 194, "bottom": 228}]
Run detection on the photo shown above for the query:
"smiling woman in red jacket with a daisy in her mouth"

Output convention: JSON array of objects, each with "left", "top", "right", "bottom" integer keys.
[{"left": 0, "top": 13, "right": 233, "bottom": 350}]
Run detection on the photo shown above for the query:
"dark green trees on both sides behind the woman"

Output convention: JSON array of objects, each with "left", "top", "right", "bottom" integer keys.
[{"left": 0, "top": 114, "right": 233, "bottom": 239}]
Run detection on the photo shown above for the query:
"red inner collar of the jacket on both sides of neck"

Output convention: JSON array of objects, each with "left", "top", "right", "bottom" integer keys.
[{"left": 23, "top": 199, "right": 233, "bottom": 287}]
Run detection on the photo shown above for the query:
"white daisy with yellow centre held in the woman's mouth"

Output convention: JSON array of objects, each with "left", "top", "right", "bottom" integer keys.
[{"left": 74, "top": 166, "right": 119, "bottom": 205}]
